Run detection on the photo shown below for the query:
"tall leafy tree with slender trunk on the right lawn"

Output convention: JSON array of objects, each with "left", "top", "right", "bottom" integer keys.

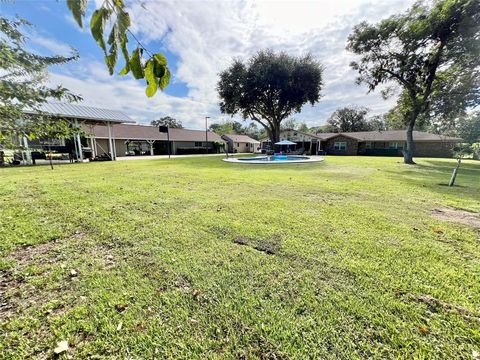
[{"left": 347, "top": 0, "right": 480, "bottom": 164}]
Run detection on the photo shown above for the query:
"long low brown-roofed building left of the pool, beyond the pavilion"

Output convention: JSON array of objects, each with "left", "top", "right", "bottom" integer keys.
[{"left": 85, "top": 124, "right": 225, "bottom": 156}]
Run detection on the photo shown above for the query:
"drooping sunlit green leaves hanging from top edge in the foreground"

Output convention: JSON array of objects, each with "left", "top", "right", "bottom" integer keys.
[{"left": 67, "top": 0, "right": 170, "bottom": 97}]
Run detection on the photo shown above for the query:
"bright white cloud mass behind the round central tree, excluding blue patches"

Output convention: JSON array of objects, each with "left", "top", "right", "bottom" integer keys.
[{"left": 47, "top": 0, "right": 413, "bottom": 128}]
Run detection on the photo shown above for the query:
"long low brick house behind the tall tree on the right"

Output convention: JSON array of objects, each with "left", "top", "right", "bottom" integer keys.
[{"left": 262, "top": 129, "right": 462, "bottom": 157}]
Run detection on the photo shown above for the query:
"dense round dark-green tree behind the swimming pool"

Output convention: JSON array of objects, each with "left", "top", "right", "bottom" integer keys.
[{"left": 217, "top": 50, "right": 323, "bottom": 142}]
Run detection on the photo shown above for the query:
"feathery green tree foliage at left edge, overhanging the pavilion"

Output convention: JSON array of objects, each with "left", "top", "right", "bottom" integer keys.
[{"left": 0, "top": 17, "right": 81, "bottom": 147}]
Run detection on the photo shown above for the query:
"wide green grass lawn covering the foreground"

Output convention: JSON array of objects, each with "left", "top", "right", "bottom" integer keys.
[{"left": 0, "top": 157, "right": 480, "bottom": 359}]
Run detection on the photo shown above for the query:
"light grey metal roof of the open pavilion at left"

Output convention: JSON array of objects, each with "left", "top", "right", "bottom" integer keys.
[{"left": 25, "top": 102, "right": 135, "bottom": 123}]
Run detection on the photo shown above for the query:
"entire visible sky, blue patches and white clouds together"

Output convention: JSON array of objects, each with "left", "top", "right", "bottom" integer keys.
[{"left": 0, "top": 0, "right": 412, "bottom": 128}]
